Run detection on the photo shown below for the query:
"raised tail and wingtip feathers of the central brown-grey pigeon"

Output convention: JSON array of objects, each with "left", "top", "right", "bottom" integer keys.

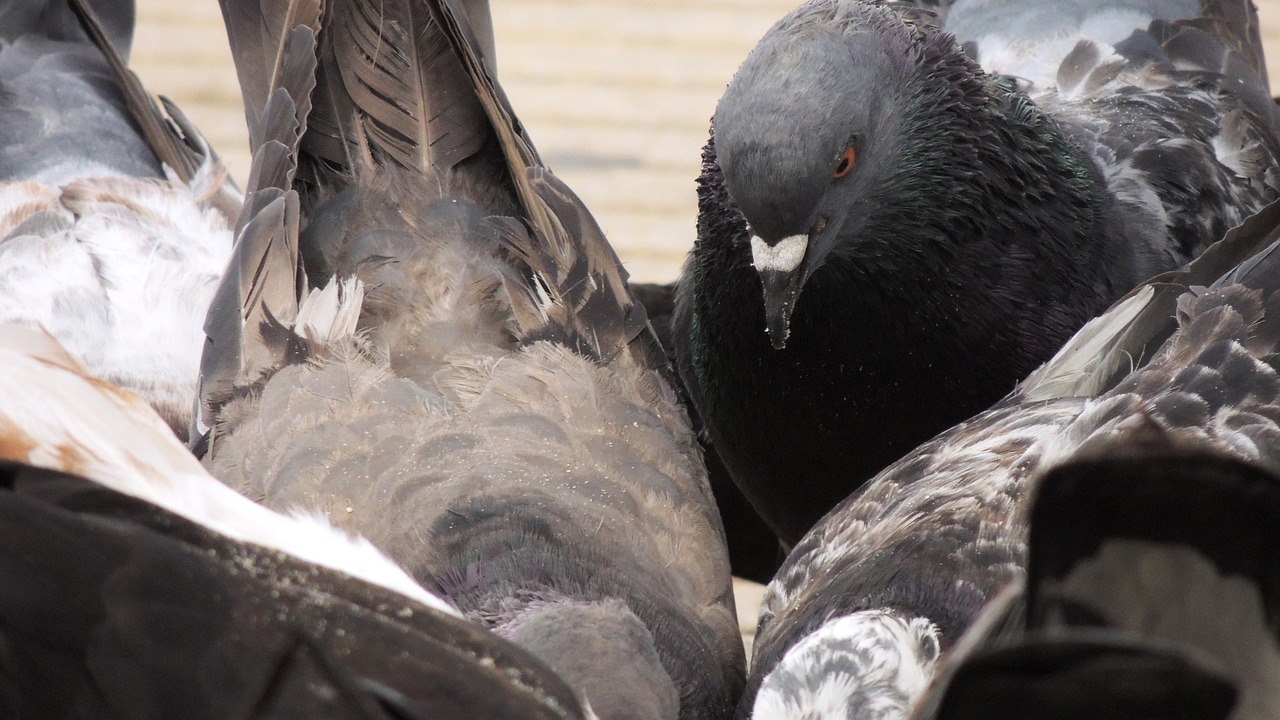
[{"left": 193, "top": 0, "right": 666, "bottom": 448}]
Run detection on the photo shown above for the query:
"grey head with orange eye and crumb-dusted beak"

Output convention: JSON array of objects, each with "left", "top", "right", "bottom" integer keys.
[{"left": 714, "top": 1, "right": 919, "bottom": 348}]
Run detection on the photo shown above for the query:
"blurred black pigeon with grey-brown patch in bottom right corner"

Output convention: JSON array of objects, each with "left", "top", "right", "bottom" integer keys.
[{"left": 914, "top": 443, "right": 1280, "bottom": 720}]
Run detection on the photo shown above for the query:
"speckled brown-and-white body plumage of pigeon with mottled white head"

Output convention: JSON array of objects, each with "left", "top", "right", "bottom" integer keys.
[{"left": 740, "top": 196, "right": 1280, "bottom": 716}]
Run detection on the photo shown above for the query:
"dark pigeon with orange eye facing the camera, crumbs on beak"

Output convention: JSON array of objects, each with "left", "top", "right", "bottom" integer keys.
[{"left": 673, "top": 0, "right": 1280, "bottom": 546}]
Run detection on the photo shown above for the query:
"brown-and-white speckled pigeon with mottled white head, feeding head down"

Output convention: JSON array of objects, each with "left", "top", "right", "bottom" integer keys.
[{"left": 739, "top": 192, "right": 1280, "bottom": 720}]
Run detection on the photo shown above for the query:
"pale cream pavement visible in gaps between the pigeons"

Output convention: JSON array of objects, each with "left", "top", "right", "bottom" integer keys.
[{"left": 132, "top": 0, "right": 1280, "bottom": 661}]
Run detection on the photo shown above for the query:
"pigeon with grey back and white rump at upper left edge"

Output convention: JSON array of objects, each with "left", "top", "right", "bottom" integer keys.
[{"left": 0, "top": 0, "right": 242, "bottom": 438}]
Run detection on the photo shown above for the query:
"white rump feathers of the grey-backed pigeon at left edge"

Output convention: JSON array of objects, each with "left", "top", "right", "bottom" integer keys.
[{"left": 0, "top": 168, "right": 232, "bottom": 428}]
